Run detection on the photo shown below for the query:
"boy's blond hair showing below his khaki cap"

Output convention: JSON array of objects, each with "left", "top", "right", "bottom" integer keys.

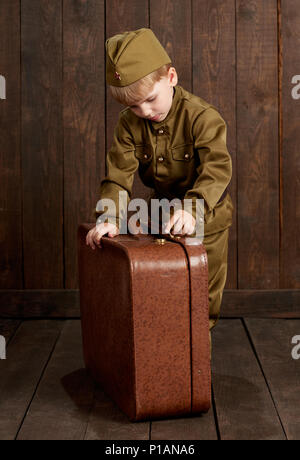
[{"left": 110, "top": 63, "right": 172, "bottom": 106}]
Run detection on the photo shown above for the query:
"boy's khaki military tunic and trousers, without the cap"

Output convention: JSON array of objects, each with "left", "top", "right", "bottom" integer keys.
[{"left": 96, "top": 85, "right": 233, "bottom": 327}]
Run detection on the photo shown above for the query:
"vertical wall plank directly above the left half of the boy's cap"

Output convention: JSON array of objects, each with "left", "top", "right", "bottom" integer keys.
[{"left": 106, "top": 0, "right": 149, "bottom": 199}]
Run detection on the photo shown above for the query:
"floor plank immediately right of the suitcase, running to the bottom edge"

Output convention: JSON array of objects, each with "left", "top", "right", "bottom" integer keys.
[{"left": 212, "top": 320, "right": 285, "bottom": 440}]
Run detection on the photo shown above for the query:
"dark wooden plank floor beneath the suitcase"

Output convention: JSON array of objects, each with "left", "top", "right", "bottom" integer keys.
[{"left": 0, "top": 318, "right": 300, "bottom": 440}]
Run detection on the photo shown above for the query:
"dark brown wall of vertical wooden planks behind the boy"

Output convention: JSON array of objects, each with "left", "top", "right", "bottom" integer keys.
[{"left": 0, "top": 0, "right": 300, "bottom": 310}]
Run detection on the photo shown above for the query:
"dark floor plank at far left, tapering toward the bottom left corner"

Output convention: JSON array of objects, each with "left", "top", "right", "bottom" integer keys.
[{"left": 0, "top": 320, "right": 62, "bottom": 440}]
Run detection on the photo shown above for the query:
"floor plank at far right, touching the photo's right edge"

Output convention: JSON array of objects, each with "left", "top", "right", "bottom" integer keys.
[{"left": 245, "top": 318, "right": 300, "bottom": 440}]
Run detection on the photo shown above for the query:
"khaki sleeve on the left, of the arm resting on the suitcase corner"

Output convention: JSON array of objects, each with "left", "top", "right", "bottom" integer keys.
[{"left": 94, "top": 113, "right": 139, "bottom": 228}]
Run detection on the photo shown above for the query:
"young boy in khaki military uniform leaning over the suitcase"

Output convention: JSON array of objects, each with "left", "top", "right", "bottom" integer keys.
[{"left": 86, "top": 28, "right": 233, "bottom": 328}]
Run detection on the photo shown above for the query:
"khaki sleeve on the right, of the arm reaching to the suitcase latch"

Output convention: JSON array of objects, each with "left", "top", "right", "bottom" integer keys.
[{"left": 184, "top": 107, "right": 232, "bottom": 217}]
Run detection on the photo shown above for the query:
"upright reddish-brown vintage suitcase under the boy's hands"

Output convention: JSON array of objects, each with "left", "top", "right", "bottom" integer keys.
[{"left": 78, "top": 224, "right": 211, "bottom": 421}]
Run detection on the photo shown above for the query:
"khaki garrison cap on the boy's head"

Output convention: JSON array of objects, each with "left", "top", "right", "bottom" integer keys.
[{"left": 105, "top": 28, "right": 171, "bottom": 86}]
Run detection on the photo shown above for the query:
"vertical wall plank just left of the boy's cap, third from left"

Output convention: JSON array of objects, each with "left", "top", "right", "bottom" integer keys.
[{"left": 63, "top": 0, "right": 105, "bottom": 288}]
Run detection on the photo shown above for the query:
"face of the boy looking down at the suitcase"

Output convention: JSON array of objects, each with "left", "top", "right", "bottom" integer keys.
[{"left": 130, "top": 67, "right": 177, "bottom": 122}]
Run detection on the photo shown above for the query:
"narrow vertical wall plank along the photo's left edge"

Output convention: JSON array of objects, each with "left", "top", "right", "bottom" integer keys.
[{"left": 0, "top": 0, "right": 23, "bottom": 289}]
